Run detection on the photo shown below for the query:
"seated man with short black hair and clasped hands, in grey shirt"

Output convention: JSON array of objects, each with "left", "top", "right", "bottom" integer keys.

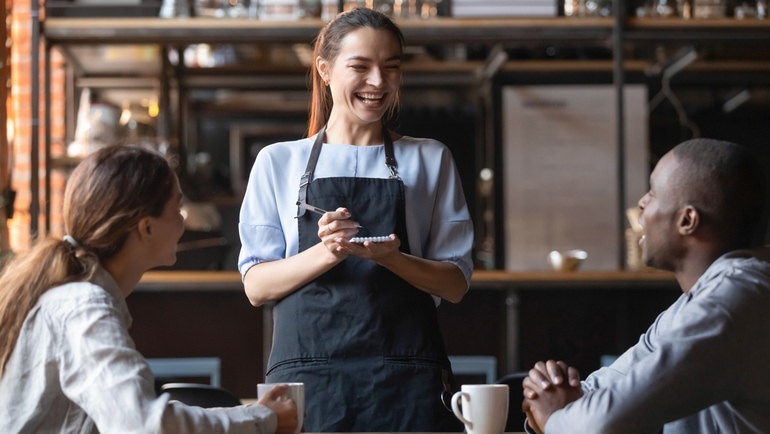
[{"left": 522, "top": 139, "right": 770, "bottom": 434}]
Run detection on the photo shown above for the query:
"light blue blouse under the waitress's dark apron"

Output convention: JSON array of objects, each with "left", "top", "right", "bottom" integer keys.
[{"left": 238, "top": 136, "right": 473, "bottom": 300}]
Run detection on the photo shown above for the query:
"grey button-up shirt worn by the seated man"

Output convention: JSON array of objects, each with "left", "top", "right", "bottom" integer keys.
[{"left": 545, "top": 248, "right": 770, "bottom": 434}]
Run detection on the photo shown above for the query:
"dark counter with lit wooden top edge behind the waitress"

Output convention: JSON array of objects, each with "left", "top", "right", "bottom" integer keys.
[{"left": 132, "top": 270, "right": 681, "bottom": 398}]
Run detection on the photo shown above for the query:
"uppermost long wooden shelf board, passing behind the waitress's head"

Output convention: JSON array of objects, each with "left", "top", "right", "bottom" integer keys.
[{"left": 43, "top": 17, "right": 770, "bottom": 45}]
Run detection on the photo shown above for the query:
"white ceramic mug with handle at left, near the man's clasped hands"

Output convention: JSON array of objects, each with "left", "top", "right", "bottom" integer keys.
[{"left": 452, "top": 384, "right": 508, "bottom": 434}]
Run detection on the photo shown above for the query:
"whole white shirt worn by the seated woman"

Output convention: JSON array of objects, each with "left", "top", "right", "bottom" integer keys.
[{"left": 0, "top": 268, "right": 277, "bottom": 434}]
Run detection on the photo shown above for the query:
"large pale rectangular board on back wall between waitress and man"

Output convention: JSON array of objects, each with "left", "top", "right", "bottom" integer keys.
[{"left": 502, "top": 85, "right": 650, "bottom": 271}]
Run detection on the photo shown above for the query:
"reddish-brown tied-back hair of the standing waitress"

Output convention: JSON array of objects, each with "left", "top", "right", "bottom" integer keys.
[{"left": 308, "top": 8, "right": 406, "bottom": 136}]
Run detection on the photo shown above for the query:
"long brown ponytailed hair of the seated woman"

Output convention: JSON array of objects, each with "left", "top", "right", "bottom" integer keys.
[{"left": 0, "top": 146, "right": 176, "bottom": 376}]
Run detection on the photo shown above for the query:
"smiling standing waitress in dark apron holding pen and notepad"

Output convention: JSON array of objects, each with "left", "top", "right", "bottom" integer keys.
[{"left": 239, "top": 8, "right": 473, "bottom": 432}]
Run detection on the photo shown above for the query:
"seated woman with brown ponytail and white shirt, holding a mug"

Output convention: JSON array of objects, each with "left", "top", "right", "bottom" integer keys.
[{"left": 0, "top": 146, "right": 297, "bottom": 434}]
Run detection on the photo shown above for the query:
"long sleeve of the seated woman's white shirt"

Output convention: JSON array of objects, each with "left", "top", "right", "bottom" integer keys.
[{"left": 60, "top": 286, "right": 276, "bottom": 433}]
